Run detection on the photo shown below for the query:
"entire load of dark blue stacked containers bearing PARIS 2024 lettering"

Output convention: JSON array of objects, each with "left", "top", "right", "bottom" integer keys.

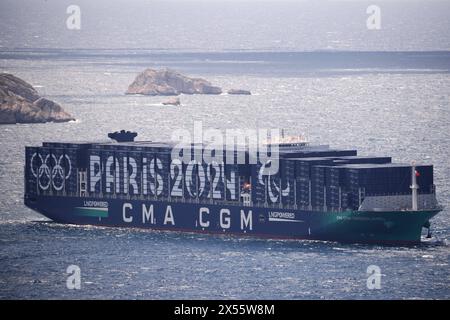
[{"left": 25, "top": 142, "right": 434, "bottom": 211}]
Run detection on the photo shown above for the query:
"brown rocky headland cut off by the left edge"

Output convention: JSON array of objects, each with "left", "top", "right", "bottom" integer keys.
[{"left": 0, "top": 73, "right": 74, "bottom": 124}]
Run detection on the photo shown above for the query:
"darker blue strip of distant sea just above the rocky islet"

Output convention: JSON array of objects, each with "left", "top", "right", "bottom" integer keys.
[{"left": 0, "top": 48, "right": 450, "bottom": 76}]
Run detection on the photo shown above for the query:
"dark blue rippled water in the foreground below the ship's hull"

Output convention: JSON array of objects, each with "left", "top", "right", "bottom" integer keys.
[{"left": 0, "top": 222, "right": 449, "bottom": 299}]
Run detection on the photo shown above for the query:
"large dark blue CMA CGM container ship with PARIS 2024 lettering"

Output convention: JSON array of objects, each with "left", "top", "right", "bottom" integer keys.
[{"left": 24, "top": 130, "right": 442, "bottom": 244}]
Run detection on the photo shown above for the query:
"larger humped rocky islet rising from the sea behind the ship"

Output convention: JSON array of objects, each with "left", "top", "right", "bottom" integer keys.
[{"left": 126, "top": 69, "right": 222, "bottom": 96}]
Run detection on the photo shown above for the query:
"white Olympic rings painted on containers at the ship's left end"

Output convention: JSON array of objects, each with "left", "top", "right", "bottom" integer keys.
[{"left": 30, "top": 152, "right": 72, "bottom": 191}]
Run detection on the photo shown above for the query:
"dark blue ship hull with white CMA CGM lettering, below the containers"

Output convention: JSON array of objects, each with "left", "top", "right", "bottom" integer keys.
[{"left": 25, "top": 196, "right": 439, "bottom": 244}]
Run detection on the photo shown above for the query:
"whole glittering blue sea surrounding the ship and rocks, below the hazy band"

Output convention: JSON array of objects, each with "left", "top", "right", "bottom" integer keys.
[{"left": 0, "top": 49, "right": 450, "bottom": 299}]
